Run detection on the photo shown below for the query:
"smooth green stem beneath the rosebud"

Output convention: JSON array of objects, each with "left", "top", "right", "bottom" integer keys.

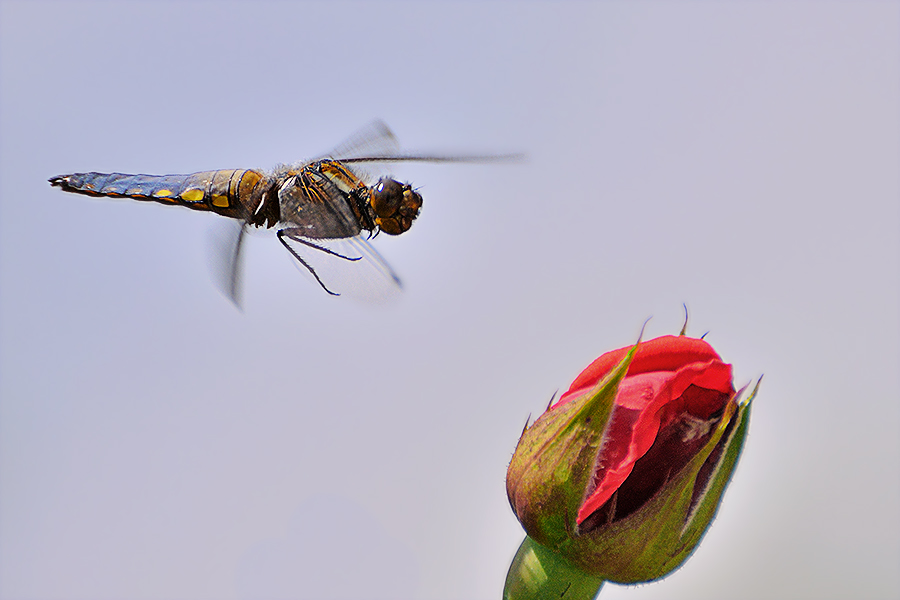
[{"left": 503, "top": 536, "right": 603, "bottom": 600}]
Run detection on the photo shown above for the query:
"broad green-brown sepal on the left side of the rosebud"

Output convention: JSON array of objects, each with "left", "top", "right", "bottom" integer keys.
[{"left": 506, "top": 344, "right": 637, "bottom": 548}]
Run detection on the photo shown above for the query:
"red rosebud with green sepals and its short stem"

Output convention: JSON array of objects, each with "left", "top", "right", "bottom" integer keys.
[{"left": 504, "top": 335, "right": 759, "bottom": 598}]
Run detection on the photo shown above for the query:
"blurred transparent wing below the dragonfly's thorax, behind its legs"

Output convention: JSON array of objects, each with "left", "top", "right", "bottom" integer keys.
[{"left": 279, "top": 230, "right": 402, "bottom": 303}]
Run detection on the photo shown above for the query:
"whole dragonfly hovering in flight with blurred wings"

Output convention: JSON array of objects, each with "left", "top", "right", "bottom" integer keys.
[{"left": 49, "top": 121, "right": 516, "bottom": 305}]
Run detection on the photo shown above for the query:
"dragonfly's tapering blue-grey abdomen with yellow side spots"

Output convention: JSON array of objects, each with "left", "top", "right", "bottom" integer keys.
[{"left": 50, "top": 169, "right": 271, "bottom": 219}]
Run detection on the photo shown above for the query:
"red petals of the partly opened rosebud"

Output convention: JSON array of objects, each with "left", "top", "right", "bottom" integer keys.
[{"left": 551, "top": 335, "right": 734, "bottom": 525}]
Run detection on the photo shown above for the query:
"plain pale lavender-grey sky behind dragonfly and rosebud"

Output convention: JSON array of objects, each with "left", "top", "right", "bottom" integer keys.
[{"left": 0, "top": 0, "right": 900, "bottom": 600}]
